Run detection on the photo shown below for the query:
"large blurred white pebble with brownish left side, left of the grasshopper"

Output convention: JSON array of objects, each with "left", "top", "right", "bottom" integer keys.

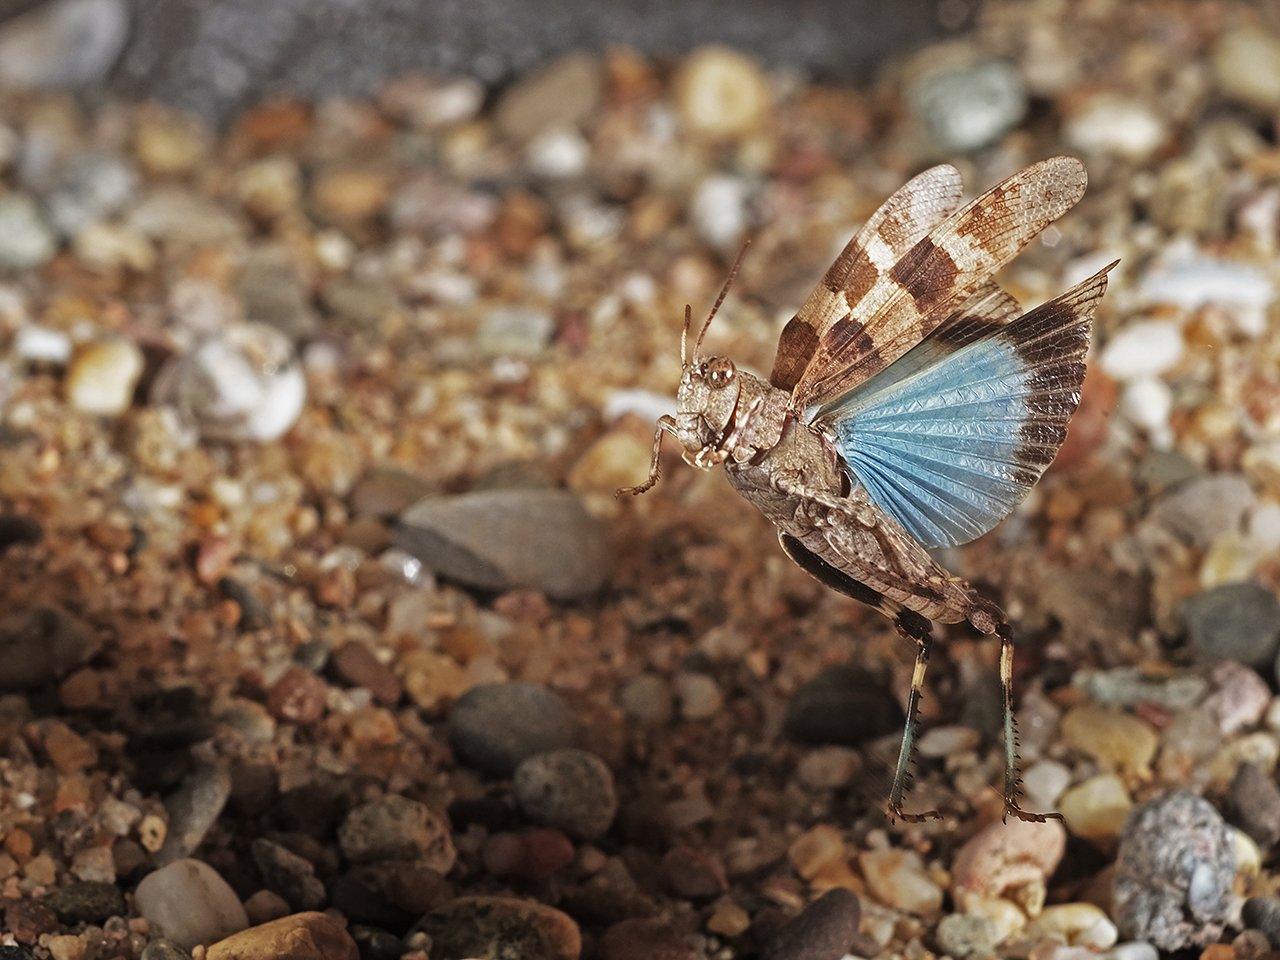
[{"left": 151, "top": 323, "right": 307, "bottom": 443}]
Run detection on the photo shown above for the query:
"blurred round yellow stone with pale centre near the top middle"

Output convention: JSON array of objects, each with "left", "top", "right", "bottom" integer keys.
[{"left": 675, "top": 46, "right": 773, "bottom": 140}]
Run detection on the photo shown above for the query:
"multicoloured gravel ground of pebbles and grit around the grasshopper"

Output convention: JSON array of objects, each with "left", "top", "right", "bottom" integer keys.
[{"left": 0, "top": 1, "right": 1280, "bottom": 960}]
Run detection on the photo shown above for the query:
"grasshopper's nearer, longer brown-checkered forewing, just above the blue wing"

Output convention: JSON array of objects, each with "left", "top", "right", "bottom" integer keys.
[{"left": 791, "top": 156, "right": 1087, "bottom": 410}]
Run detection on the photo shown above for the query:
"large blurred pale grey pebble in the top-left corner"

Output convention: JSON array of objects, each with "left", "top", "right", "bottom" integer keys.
[{"left": 0, "top": 0, "right": 129, "bottom": 90}]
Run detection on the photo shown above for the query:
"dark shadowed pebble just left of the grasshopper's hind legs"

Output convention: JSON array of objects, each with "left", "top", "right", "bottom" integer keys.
[{"left": 783, "top": 666, "right": 905, "bottom": 746}]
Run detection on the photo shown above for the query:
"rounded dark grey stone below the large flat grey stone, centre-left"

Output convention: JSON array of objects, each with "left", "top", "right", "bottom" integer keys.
[{"left": 449, "top": 682, "right": 577, "bottom": 778}]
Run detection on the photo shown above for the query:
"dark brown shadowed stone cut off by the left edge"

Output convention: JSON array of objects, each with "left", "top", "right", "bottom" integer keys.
[{"left": 0, "top": 607, "right": 102, "bottom": 691}]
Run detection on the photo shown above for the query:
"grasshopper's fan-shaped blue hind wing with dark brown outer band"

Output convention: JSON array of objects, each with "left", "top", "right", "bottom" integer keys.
[{"left": 814, "top": 268, "right": 1110, "bottom": 547}]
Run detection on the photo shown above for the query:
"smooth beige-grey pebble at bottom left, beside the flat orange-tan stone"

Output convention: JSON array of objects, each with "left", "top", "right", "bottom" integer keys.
[{"left": 133, "top": 860, "right": 248, "bottom": 950}]
